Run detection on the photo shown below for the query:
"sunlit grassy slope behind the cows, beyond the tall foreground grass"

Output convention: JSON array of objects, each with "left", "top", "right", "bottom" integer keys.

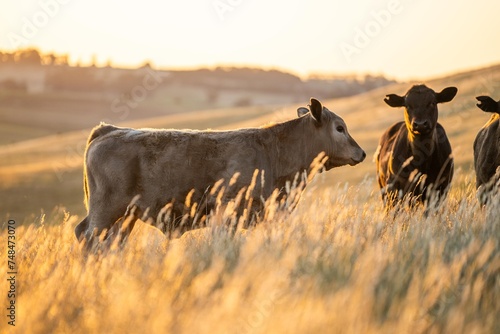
[{"left": 0, "top": 66, "right": 500, "bottom": 220}]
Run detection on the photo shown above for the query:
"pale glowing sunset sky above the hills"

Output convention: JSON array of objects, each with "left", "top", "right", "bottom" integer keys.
[{"left": 0, "top": 0, "right": 500, "bottom": 80}]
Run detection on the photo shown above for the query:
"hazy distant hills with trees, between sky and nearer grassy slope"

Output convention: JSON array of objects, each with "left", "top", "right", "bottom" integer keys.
[{"left": 0, "top": 49, "right": 393, "bottom": 145}]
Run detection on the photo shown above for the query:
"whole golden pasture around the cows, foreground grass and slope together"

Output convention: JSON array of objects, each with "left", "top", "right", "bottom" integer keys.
[{"left": 0, "top": 66, "right": 500, "bottom": 333}]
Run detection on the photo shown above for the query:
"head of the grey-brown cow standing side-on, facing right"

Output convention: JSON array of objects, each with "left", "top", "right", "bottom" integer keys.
[{"left": 297, "top": 98, "right": 366, "bottom": 170}]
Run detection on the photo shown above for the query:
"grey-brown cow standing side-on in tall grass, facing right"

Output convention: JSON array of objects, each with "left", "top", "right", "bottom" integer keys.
[{"left": 75, "top": 99, "right": 366, "bottom": 248}]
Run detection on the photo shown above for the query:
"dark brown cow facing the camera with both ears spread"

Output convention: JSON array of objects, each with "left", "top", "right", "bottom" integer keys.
[{"left": 375, "top": 85, "right": 457, "bottom": 208}]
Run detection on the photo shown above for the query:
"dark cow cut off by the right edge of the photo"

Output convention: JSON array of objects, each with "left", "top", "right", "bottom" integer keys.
[{"left": 474, "top": 96, "right": 500, "bottom": 204}]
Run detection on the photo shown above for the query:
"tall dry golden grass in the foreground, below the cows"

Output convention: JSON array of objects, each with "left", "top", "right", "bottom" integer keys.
[{"left": 0, "top": 172, "right": 500, "bottom": 334}]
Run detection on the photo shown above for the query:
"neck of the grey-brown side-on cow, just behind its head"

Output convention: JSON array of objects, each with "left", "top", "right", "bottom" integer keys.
[{"left": 268, "top": 117, "right": 320, "bottom": 186}]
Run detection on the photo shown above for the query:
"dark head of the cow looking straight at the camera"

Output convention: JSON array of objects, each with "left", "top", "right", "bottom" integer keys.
[{"left": 384, "top": 85, "right": 458, "bottom": 135}]
